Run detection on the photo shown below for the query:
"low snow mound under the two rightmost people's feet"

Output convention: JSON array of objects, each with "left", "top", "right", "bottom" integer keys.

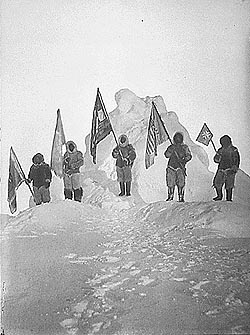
[{"left": 137, "top": 201, "right": 250, "bottom": 238}]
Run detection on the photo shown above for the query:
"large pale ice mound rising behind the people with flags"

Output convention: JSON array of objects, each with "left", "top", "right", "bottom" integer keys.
[{"left": 79, "top": 89, "right": 250, "bottom": 204}]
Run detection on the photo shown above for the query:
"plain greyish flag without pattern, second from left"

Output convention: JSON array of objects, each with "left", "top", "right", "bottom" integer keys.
[{"left": 50, "top": 109, "right": 66, "bottom": 178}]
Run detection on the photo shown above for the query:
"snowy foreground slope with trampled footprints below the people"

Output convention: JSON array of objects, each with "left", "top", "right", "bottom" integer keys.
[{"left": 2, "top": 201, "right": 250, "bottom": 335}]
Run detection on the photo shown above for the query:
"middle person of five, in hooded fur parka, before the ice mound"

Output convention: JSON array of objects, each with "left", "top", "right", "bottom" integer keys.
[{"left": 112, "top": 134, "right": 136, "bottom": 196}]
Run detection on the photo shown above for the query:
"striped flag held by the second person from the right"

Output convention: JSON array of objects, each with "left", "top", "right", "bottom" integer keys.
[{"left": 145, "top": 102, "right": 169, "bottom": 169}]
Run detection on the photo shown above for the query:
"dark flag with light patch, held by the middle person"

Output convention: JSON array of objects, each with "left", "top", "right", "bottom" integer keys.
[{"left": 90, "top": 88, "right": 112, "bottom": 164}]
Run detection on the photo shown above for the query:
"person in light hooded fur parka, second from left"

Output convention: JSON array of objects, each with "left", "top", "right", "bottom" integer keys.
[{"left": 63, "top": 141, "right": 83, "bottom": 202}]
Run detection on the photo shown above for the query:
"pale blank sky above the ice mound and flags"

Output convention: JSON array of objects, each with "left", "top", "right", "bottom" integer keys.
[{"left": 1, "top": 0, "right": 250, "bottom": 212}]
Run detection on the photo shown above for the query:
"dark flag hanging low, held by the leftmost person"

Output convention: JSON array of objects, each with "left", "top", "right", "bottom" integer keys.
[{"left": 7, "top": 147, "right": 26, "bottom": 214}]
